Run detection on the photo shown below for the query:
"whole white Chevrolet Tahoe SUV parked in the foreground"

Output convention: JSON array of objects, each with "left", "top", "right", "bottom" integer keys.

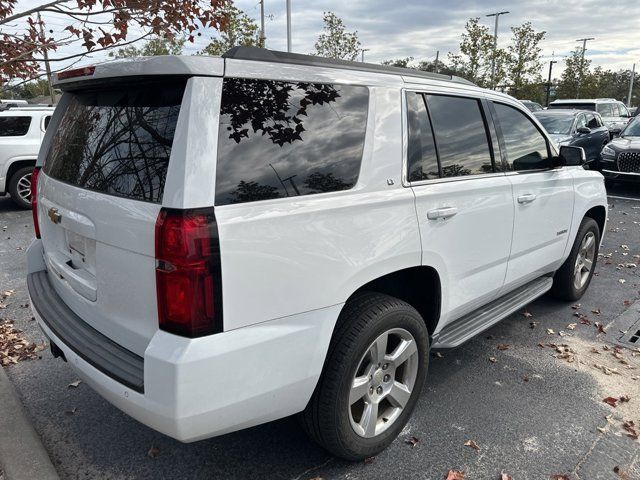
[{"left": 28, "top": 47, "right": 607, "bottom": 459}]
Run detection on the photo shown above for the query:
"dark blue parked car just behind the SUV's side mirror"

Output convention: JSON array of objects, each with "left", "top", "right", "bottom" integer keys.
[{"left": 534, "top": 109, "right": 610, "bottom": 169}]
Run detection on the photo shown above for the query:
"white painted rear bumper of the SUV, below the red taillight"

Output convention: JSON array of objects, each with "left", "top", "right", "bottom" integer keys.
[{"left": 29, "top": 241, "right": 341, "bottom": 442}]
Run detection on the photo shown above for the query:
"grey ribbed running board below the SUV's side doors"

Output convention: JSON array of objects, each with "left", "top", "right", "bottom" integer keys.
[{"left": 431, "top": 276, "right": 553, "bottom": 349}]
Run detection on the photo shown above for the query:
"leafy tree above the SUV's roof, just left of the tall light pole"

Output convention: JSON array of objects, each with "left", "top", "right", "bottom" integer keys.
[{"left": 448, "top": 18, "right": 498, "bottom": 86}]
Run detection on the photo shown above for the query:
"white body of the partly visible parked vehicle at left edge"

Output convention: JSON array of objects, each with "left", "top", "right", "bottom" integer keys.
[{"left": 0, "top": 108, "right": 53, "bottom": 193}]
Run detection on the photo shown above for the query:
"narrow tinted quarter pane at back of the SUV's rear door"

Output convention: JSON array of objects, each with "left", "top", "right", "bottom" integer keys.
[{"left": 407, "top": 92, "right": 439, "bottom": 182}]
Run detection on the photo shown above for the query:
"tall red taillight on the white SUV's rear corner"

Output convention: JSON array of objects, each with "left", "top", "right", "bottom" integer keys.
[{"left": 156, "top": 208, "right": 222, "bottom": 337}]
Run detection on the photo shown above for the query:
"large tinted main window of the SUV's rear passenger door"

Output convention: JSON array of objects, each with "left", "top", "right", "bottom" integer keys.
[{"left": 427, "top": 95, "right": 493, "bottom": 177}]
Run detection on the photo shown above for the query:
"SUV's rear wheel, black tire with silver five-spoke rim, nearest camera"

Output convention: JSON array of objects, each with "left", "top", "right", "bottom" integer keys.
[{"left": 301, "top": 293, "right": 429, "bottom": 460}]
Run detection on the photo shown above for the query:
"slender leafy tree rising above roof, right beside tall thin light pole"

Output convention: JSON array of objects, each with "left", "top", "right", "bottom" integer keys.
[{"left": 505, "top": 22, "right": 546, "bottom": 97}]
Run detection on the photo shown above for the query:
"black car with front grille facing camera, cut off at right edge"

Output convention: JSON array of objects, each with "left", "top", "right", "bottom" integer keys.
[{"left": 601, "top": 117, "right": 640, "bottom": 182}]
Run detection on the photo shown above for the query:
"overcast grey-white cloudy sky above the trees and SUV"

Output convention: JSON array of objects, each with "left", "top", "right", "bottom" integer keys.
[{"left": 8, "top": 0, "right": 640, "bottom": 77}]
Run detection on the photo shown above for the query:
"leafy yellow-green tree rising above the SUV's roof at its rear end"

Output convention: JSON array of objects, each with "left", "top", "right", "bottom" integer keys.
[{"left": 201, "top": 4, "right": 264, "bottom": 56}]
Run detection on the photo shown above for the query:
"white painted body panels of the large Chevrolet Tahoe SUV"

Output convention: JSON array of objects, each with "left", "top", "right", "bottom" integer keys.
[{"left": 28, "top": 57, "right": 606, "bottom": 441}]
